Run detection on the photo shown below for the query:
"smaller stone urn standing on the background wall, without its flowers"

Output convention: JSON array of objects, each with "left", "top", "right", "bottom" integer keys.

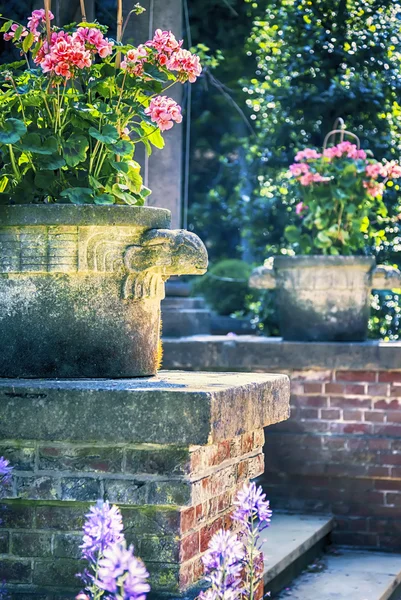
[{"left": 249, "top": 256, "right": 401, "bottom": 341}]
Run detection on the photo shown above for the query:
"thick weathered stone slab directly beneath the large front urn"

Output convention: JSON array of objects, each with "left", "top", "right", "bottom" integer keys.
[{"left": 0, "top": 371, "right": 290, "bottom": 445}]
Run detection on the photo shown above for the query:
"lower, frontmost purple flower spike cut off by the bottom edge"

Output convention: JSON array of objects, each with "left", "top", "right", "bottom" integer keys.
[{"left": 96, "top": 542, "right": 150, "bottom": 600}]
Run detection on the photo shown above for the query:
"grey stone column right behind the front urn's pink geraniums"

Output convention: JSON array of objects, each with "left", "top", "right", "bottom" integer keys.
[{"left": 124, "top": 0, "right": 183, "bottom": 228}]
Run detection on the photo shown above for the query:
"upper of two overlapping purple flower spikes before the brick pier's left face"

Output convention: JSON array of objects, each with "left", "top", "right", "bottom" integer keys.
[{"left": 81, "top": 500, "right": 124, "bottom": 562}]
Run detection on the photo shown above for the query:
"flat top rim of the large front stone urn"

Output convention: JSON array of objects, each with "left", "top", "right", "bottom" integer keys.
[{"left": 0, "top": 204, "right": 171, "bottom": 229}]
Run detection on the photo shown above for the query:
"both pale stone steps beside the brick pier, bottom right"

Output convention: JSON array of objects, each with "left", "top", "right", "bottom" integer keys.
[{"left": 263, "top": 513, "right": 401, "bottom": 600}]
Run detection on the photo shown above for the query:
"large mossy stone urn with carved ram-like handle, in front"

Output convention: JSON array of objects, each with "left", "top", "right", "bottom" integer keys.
[{"left": 0, "top": 205, "right": 207, "bottom": 378}]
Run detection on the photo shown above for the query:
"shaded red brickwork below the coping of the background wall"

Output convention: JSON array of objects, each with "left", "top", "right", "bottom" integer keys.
[{"left": 263, "top": 365, "right": 401, "bottom": 550}]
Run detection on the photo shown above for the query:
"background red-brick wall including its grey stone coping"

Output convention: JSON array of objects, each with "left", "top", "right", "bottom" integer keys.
[{"left": 164, "top": 336, "right": 401, "bottom": 550}]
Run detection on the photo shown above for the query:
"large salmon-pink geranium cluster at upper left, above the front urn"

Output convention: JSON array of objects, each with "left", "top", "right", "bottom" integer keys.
[{"left": 34, "top": 27, "right": 113, "bottom": 79}]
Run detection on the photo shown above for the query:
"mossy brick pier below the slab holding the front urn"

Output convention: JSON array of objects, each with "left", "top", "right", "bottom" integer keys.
[{"left": 0, "top": 429, "right": 264, "bottom": 600}]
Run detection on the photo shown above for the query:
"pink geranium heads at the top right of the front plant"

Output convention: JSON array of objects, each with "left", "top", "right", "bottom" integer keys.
[{"left": 121, "top": 29, "right": 202, "bottom": 83}]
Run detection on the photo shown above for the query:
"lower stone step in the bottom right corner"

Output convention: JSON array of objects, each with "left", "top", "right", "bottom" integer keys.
[{"left": 273, "top": 549, "right": 401, "bottom": 600}]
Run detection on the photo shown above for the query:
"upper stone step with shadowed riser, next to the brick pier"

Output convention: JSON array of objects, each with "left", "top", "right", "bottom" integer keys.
[{"left": 262, "top": 513, "right": 332, "bottom": 600}]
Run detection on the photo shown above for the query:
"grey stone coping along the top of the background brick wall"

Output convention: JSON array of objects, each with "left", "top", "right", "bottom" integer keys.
[{"left": 163, "top": 335, "right": 401, "bottom": 372}]
